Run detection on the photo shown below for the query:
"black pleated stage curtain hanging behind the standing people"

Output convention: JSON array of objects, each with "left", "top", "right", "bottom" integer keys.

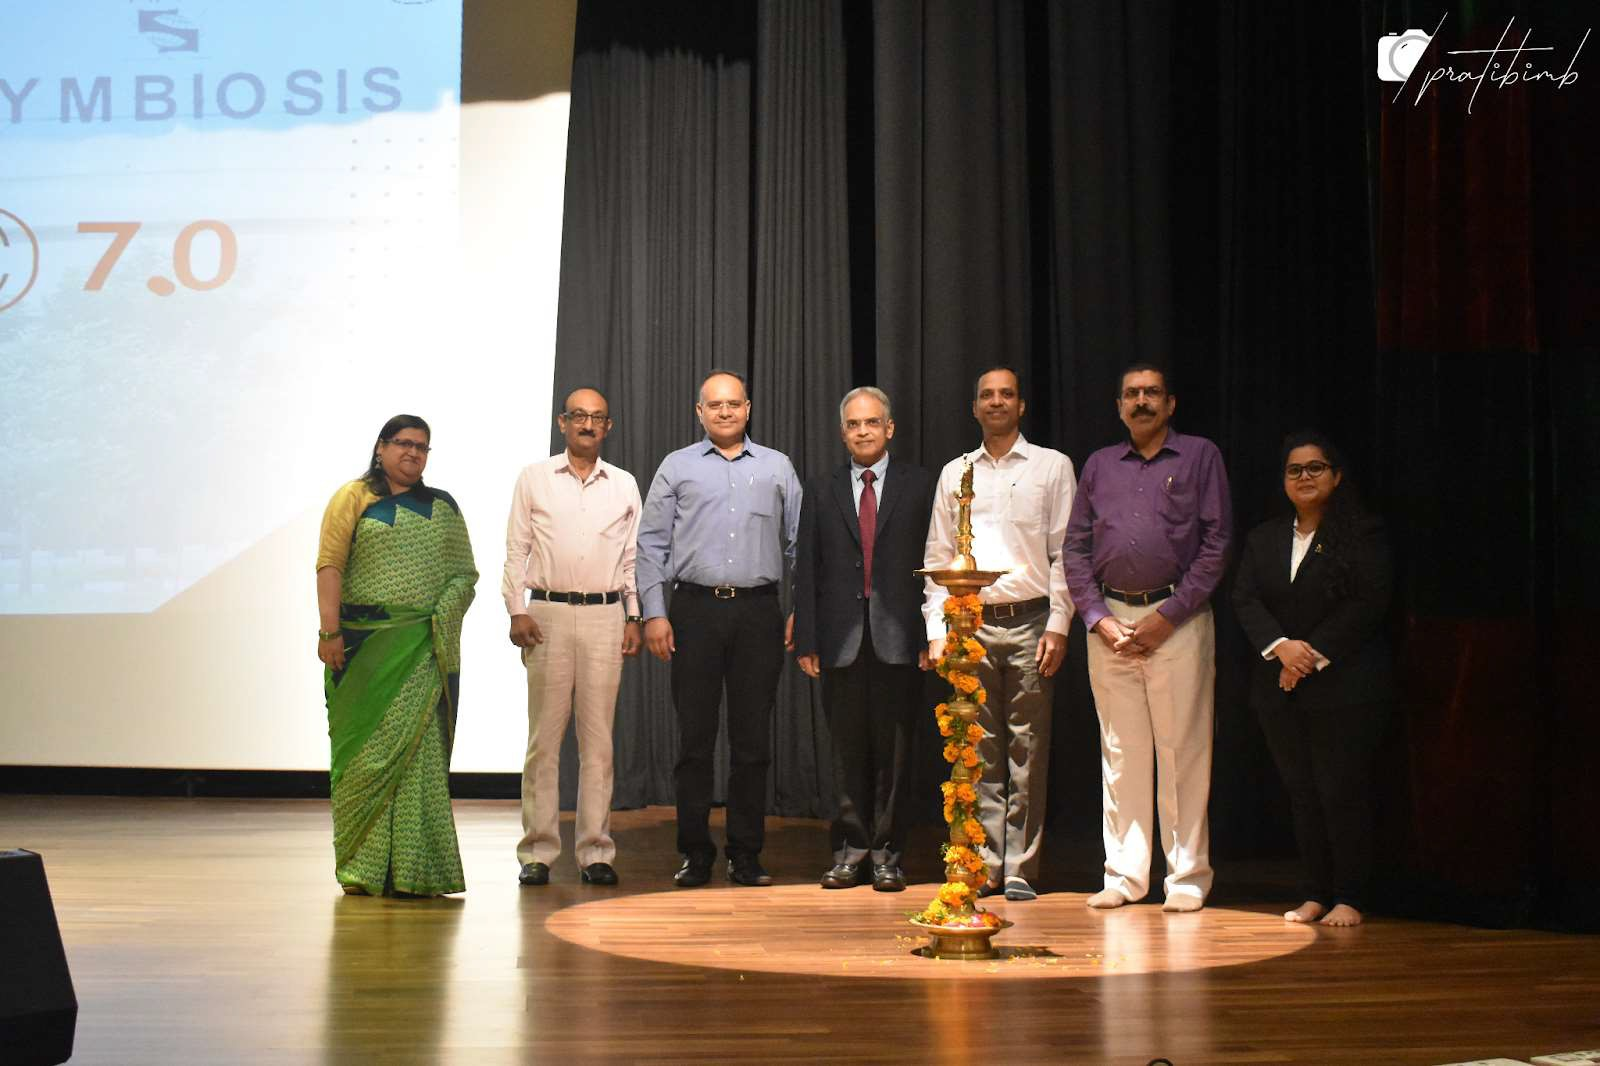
[{"left": 557, "top": 0, "right": 1600, "bottom": 927}]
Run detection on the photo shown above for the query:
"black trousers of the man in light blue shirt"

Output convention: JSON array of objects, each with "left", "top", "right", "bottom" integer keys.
[{"left": 667, "top": 589, "right": 784, "bottom": 856}]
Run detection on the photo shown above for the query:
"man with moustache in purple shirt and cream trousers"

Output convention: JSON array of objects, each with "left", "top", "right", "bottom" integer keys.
[{"left": 1064, "top": 363, "right": 1232, "bottom": 911}]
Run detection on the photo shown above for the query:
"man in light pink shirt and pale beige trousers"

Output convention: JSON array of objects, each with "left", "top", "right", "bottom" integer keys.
[{"left": 501, "top": 389, "right": 642, "bottom": 885}]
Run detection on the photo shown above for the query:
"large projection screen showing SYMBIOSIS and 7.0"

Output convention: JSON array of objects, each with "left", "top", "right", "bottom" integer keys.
[{"left": 0, "top": 0, "right": 573, "bottom": 771}]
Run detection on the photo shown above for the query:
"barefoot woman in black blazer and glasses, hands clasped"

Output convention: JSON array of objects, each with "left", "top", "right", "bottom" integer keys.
[{"left": 1234, "top": 431, "right": 1392, "bottom": 925}]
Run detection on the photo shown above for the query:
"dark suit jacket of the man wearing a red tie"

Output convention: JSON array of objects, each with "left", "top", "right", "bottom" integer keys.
[{"left": 794, "top": 456, "right": 936, "bottom": 669}]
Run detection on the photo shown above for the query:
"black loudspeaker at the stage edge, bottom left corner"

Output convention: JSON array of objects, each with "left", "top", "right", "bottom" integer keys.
[{"left": 0, "top": 850, "right": 78, "bottom": 1066}]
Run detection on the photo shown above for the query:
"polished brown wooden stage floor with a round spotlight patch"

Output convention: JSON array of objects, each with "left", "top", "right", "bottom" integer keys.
[{"left": 0, "top": 795, "right": 1600, "bottom": 1066}]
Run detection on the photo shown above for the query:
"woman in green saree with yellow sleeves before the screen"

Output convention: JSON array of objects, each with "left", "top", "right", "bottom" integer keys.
[{"left": 317, "top": 415, "right": 478, "bottom": 896}]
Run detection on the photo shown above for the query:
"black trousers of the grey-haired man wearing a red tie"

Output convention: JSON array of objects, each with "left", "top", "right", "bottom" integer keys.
[{"left": 822, "top": 618, "right": 922, "bottom": 866}]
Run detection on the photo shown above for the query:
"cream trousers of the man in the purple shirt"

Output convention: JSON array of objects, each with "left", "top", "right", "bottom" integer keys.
[{"left": 1088, "top": 599, "right": 1216, "bottom": 901}]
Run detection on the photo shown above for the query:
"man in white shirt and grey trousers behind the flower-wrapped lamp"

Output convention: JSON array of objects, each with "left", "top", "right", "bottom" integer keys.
[{"left": 923, "top": 367, "right": 1077, "bottom": 900}]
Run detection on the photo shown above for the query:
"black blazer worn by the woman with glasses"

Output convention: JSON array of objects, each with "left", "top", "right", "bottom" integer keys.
[{"left": 1234, "top": 515, "right": 1394, "bottom": 711}]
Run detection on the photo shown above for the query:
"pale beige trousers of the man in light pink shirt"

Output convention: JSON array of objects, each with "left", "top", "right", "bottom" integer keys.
[{"left": 517, "top": 600, "right": 622, "bottom": 866}]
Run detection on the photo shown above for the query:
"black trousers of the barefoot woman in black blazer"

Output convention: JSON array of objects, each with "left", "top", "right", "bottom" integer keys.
[{"left": 1258, "top": 693, "right": 1389, "bottom": 911}]
